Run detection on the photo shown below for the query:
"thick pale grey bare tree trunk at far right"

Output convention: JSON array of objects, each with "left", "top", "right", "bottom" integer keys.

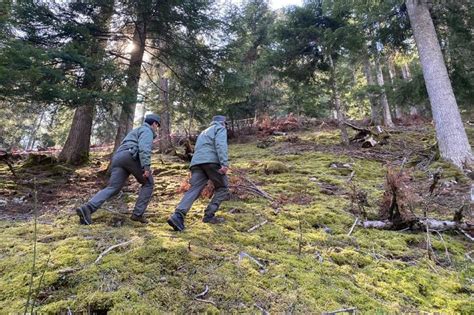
[{"left": 406, "top": 0, "right": 472, "bottom": 168}]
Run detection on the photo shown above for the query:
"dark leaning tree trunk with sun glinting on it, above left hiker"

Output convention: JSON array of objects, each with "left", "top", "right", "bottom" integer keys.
[{"left": 114, "top": 16, "right": 147, "bottom": 152}]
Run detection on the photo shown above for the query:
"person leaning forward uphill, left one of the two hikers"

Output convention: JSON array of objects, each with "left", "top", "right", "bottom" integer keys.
[{"left": 76, "top": 114, "right": 160, "bottom": 225}]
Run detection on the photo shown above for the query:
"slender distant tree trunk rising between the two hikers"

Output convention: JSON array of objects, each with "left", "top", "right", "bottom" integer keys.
[{"left": 158, "top": 66, "right": 173, "bottom": 153}]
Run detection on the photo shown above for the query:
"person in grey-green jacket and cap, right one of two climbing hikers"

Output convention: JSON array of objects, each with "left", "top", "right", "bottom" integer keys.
[{"left": 167, "top": 116, "right": 229, "bottom": 231}]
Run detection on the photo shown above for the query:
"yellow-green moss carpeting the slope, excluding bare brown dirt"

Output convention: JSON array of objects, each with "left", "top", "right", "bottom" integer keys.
[{"left": 0, "top": 125, "right": 474, "bottom": 314}]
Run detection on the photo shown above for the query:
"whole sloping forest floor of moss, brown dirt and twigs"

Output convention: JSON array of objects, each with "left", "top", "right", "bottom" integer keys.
[{"left": 0, "top": 125, "right": 474, "bottom": 314}]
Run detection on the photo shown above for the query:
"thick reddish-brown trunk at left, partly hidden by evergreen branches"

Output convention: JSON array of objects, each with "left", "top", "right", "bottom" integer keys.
[{"left": 59, "top": 0, "right": 114, "bottom": 165}]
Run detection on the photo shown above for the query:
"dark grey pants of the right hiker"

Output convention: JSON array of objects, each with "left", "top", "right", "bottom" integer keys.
[{"left": 176, "top": 163, "right": 229, "bottom": 217}]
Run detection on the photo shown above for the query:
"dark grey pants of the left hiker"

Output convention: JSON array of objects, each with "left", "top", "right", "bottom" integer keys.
[{"left": 86, "top": 150, "right": 154, "bottom": 216}]
